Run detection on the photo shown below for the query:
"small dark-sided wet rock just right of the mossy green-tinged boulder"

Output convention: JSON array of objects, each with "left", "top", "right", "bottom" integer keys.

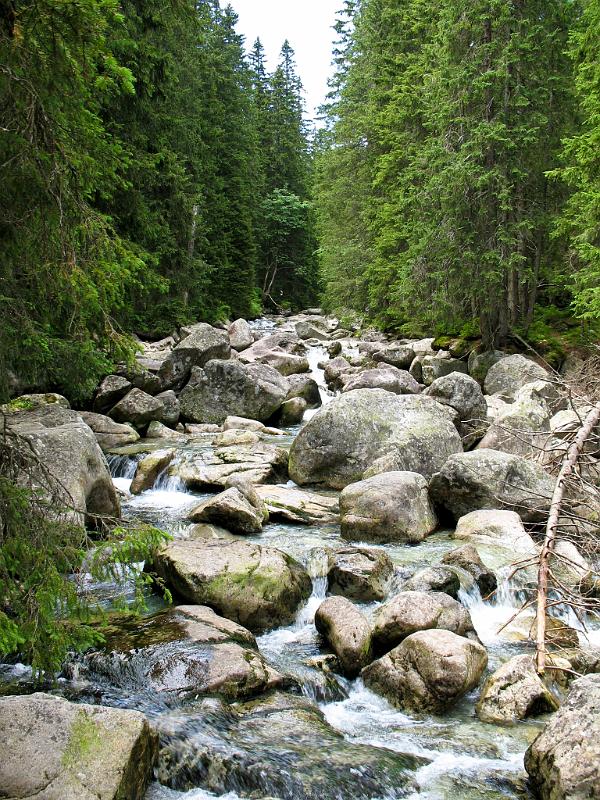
[{"left": 328, "top": 547, "right": 394, "bottom": 603}]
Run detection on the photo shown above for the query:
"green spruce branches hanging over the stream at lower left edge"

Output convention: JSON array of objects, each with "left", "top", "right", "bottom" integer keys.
[{"left": 0, "top": 436, "right": 168, "bottom": 676}]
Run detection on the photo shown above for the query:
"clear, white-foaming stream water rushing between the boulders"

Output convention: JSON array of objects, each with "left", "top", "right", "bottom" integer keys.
[{"left": 0, "top": 322, "right": 600, "bottom": 800}]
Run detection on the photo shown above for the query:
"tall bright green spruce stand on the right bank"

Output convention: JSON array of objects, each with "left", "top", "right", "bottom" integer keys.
[{"left": 317, "top": 0, "right": 576, "bottom": 346}]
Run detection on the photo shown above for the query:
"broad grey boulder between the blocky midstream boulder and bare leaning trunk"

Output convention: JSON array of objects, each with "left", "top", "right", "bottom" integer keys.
[{"left": 429, "top": 450, "right": 554, "bottom": 522}]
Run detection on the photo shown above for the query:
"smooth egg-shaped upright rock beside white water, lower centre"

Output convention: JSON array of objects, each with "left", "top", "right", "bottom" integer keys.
[{"left": 315, "top": 597, "right": 372, "bottom": 678}]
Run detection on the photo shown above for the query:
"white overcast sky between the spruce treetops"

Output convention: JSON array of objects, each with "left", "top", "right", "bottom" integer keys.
[{"left": 230, "top": 0, "right": 342, "bottom": 117}]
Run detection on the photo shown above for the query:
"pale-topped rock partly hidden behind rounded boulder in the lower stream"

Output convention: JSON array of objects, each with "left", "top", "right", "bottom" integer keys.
[{"left": 373, "top": 591, "right": 477, "bottom": 653}]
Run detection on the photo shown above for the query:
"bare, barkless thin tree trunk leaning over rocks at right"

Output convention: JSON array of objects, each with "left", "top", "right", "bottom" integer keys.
[{"left": 536, "top": 403, "right": 600, "bottom": 675}]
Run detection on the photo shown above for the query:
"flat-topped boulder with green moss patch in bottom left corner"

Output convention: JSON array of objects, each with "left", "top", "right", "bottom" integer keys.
[{"left": 0, "top": 694, "right": 158, "bottom": 800}]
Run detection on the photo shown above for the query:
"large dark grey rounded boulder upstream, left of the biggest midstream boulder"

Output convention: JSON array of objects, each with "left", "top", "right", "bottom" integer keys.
[{"left": 179, "top": 360, "right": 288, "bottom": 425}]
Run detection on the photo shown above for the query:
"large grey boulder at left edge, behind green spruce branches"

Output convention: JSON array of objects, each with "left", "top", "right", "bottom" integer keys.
[{"left": 5, "top": 404, "right": 121, "bottom": 527}]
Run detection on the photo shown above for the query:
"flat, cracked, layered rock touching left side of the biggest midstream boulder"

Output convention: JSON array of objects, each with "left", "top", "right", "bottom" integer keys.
[{"left": 170, "top": 444, "right": 288, "bottom": 491}]
